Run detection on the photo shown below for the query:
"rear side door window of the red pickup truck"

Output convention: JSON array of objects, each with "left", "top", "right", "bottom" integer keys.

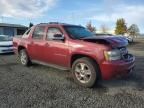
[{"left": 33, "top": 26, "right": 45, "bottom": 39}]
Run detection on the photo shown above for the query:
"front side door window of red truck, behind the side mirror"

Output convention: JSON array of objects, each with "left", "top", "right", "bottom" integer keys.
[{"left": 47, "top": 28, "right": 62, "bottom": 40}]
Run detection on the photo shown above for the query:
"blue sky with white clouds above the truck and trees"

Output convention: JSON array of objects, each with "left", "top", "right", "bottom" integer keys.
[{"left": 0, "top": 0, "right": 144, "bottom": 33}]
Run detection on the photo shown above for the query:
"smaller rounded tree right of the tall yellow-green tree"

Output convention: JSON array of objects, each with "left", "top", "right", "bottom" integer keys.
[{"left": 128, "top": 24, "right": 140, "bottom": 37}]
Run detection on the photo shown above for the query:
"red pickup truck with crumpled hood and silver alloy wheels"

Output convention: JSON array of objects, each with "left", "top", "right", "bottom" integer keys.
[{"left": 13, "top": 23, "right": 135, "bottom": 87}]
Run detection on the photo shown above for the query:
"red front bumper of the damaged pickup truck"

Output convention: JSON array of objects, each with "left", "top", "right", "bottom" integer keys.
[{"left": 100, "top": 54, "right": 135, "bottom": 80}]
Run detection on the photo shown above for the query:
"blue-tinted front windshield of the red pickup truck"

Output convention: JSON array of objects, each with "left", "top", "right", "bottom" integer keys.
[{"left": 64, "top": 26, "right": 93, "bottom": 39}]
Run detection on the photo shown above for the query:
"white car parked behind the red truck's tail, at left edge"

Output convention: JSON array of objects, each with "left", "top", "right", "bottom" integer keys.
[{"left": 0, "top": 35, "right": 14, "bottom": 54}]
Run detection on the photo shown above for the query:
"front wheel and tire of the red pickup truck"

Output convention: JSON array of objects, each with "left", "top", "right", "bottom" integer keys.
[{"left": 72, "top": 57, "right": 99, "bottom": 88}]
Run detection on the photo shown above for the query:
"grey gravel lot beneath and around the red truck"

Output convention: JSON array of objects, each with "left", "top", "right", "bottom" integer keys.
[{"left": 0, "top": 40, "right": 144, "bottom": 108}]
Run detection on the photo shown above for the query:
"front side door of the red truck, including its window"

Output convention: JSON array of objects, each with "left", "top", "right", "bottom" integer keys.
[{"left": 45, "top": 26, "right": 69, "bottom": 67}]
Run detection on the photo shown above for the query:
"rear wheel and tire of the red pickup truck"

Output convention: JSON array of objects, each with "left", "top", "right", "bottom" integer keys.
[{"left": 19, "top": 49, "right": 31, "bottom": 66}]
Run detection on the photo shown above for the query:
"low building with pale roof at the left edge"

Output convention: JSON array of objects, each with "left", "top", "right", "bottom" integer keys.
[{"left": 0, "top": 23, "right": 28, "bottom": 36}]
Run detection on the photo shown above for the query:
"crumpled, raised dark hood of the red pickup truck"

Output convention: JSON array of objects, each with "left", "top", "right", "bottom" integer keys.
[{"left": 83, "top": 36, "right": 128, "bottom": 47}]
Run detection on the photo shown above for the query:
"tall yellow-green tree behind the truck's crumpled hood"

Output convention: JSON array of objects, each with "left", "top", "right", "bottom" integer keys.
[{"left": 115, "top": 18, "right": 127, "bottom": 35}]
